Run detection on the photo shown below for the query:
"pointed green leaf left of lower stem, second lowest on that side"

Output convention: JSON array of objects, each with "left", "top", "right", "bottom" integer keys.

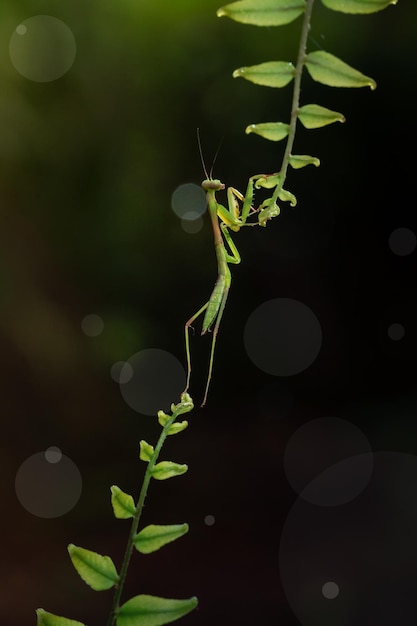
[{"left": 68, "top": 543, "right": 119, "bottom": 591}]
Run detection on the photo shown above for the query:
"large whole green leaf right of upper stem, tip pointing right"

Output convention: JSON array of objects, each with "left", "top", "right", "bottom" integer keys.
[{"left": 305, "top": 50, "right": 376, "bottom": 89}]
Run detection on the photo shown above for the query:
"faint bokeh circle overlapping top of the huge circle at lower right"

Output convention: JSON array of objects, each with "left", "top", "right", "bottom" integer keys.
[{"left": 284, "top": 417, "right": 373, "bottom": 506}]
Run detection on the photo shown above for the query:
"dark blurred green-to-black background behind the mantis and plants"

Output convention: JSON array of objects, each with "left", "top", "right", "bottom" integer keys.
[{"left": 0, "top": 0, "right": 417, "bottom": 626}]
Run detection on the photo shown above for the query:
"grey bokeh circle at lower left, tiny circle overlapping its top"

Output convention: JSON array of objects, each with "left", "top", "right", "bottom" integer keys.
[{"left": 15, "top": 446, "right": 82, "bottom": 518}]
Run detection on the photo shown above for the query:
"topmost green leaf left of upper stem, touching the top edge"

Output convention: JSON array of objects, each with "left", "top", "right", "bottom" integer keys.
[{"left": 217, "top": 0, "right": 306, "bottom": 26}]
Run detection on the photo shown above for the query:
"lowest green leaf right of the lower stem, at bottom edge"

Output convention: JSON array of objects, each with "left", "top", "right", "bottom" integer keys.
[{"left": 117, "top": 595, "right": 198, "bottom": 626}]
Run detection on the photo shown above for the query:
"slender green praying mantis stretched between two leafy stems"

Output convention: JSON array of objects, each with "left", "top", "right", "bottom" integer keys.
[{"left": 184, "top": 172, "right": 257, "bottom": 406}]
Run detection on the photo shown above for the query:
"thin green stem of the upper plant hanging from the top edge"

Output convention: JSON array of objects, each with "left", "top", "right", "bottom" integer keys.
[{"left": 272, "top": 0, "right": 314, "bottom": 202}]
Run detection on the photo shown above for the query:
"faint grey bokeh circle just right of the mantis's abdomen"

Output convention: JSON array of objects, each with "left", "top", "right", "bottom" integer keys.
[{"left": 244, "top": 298, "right": 322, "bottom": 376}]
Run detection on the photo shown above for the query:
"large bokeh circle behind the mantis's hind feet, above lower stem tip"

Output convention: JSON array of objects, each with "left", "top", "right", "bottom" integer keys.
[{"left": 120, "top": 348, "right": 185, "bottom": 416}]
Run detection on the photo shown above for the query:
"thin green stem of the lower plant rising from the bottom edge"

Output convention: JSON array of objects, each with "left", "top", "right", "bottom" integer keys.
[{"left": 107, "top": 409, "right": 181, "bottom": 626}]
